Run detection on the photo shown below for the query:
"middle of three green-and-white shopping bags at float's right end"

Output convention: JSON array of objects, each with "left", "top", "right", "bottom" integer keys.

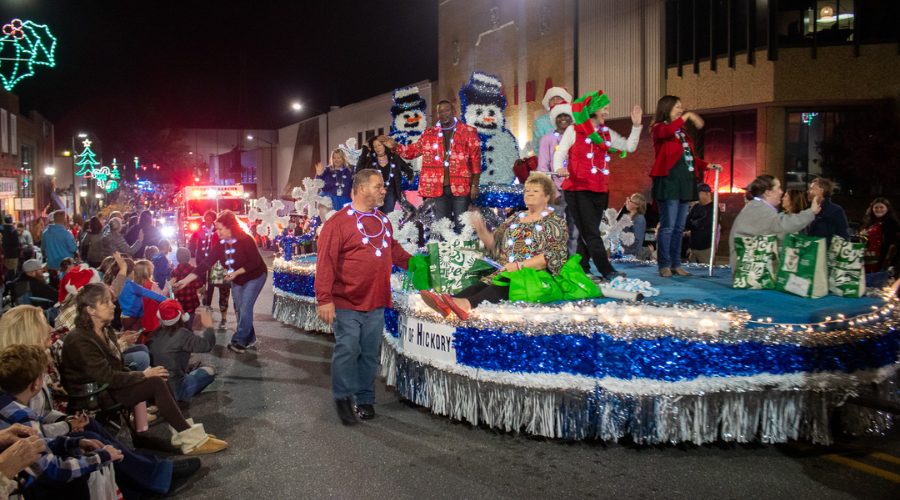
[{"left": 775, "top": 234, "right": 828, "bottom": 299}]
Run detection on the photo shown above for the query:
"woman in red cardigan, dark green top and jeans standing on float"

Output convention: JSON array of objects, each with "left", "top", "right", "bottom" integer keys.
[{"left": 650, "top": 95, "right": 722, "bottom": 278}]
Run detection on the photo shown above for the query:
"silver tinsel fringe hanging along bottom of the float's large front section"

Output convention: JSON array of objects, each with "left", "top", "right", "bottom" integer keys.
[{"left": 381, "top": 341, "right": 897, "bottom": 445}]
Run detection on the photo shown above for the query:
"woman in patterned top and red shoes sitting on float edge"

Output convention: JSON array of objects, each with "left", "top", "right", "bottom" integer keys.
[{"left": 419, "top": 172, "right": 569, "bottom": 319}]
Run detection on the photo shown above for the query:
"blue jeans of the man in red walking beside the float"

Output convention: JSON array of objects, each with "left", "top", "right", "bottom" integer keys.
[{"left": 331, "top": 307, "right": 384, "bottom": 405}]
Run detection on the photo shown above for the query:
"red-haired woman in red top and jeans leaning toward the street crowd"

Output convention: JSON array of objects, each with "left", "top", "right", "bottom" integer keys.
[{"left": 172, "top": 210, "right": 268, "bottom": 353}]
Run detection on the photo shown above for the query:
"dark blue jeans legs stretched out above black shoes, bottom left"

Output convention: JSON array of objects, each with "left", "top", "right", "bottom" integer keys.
[{"left": 69, "top": 418, "right": 172, "bottom": 493}]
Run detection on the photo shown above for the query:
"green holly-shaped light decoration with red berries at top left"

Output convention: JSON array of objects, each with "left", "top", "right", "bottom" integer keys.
[{"left": 0, "top": 19, "right": 56, "bottom": 90}]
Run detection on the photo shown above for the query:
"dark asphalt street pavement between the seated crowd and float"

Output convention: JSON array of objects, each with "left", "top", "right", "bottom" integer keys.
[{"left": 137, "top": 252, "right": 900, "bottom": 500}]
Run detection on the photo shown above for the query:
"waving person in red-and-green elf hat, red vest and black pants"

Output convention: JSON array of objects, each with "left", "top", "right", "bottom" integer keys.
[{"left": 553, "top": 90, "right": 643, "bottom": 280}]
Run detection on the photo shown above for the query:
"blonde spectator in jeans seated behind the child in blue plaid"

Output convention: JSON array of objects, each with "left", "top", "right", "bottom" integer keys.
[{"left": 0, "top": 306, "right": 200, "bottom": 498}]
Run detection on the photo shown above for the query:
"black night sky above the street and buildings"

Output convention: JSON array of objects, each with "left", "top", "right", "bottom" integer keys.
[{"left": 0, "top": 0, "right": 438, "bottom": 142}]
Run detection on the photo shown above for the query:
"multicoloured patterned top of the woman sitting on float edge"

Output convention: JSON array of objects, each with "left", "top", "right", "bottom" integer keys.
[{"left": 482, "top": 209, "right": 569, "bottom": 283}]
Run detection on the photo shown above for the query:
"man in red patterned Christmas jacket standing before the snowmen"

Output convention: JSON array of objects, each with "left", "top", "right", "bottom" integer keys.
[{"left": 378, "top": 100, "right": 481, "bottom": 230}]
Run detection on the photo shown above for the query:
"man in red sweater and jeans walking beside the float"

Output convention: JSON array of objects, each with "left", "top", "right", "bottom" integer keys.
[{"left": 315, "top": 168, "right": 410, "bottom": 425}]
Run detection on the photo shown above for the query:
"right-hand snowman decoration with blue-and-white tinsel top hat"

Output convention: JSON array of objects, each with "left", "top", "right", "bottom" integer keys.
[{"left": 459, "top": 71, "right": 519, "bottom": 185}]
